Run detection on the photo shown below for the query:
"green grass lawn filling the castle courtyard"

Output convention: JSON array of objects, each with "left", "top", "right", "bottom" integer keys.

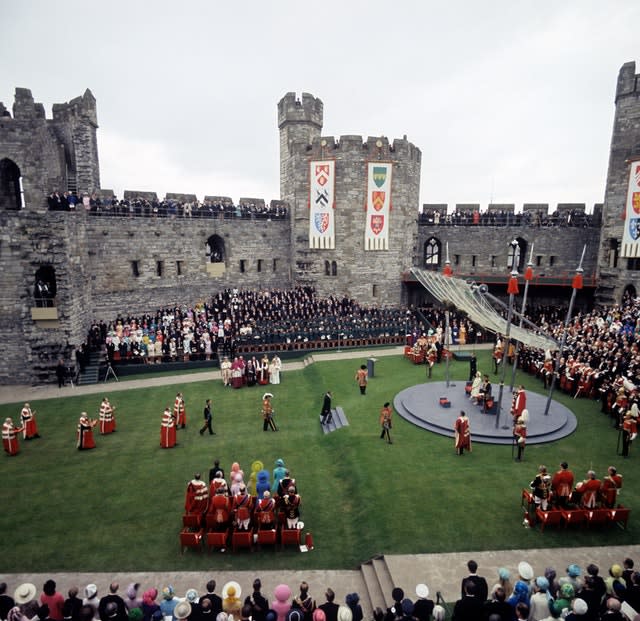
[{"left": 0, "top": 352, "right": 640, "bottom": 572}]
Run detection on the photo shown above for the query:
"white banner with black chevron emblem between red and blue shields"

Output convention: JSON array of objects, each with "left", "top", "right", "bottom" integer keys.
[{"left": 309, "top": 160, "right": 336, "bottom": 250}]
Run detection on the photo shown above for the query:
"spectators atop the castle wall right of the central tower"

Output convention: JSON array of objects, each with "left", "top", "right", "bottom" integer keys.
[{"left": 418, "top": 208, "right": 600, "bottom": 228}]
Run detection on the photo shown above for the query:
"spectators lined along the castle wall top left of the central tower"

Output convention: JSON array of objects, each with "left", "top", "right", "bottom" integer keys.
[{"left": 47, "top": 190, "right": 288, "bottom": 220}]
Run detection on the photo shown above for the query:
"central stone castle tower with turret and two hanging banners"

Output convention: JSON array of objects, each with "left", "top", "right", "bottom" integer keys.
[{"left": 278, "top": 93, "right": 421, "bottom": 304}]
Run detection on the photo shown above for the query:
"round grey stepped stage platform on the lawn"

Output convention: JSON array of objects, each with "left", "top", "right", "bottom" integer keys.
[{"left": 393, "top": 381, "right": 578, "bottom": 444}]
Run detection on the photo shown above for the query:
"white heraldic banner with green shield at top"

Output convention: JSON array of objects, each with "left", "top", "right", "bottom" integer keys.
[{"left": 364, "top": 162, "right": 393, "bottom": 250}]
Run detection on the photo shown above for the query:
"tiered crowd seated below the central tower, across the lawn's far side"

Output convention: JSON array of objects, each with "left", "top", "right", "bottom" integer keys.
[{"left": 88, "top": 287, "right": 477, "bottom": 362}]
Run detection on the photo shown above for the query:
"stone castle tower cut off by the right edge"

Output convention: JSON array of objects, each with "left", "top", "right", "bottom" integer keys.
[{"left": 596, "top": 62, "right": 640, "bottom": 304}]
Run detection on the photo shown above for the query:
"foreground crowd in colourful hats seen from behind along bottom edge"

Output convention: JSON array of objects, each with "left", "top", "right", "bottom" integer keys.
[{"left": 0, "top": 557, "right": 640, "bottom": 621}]
